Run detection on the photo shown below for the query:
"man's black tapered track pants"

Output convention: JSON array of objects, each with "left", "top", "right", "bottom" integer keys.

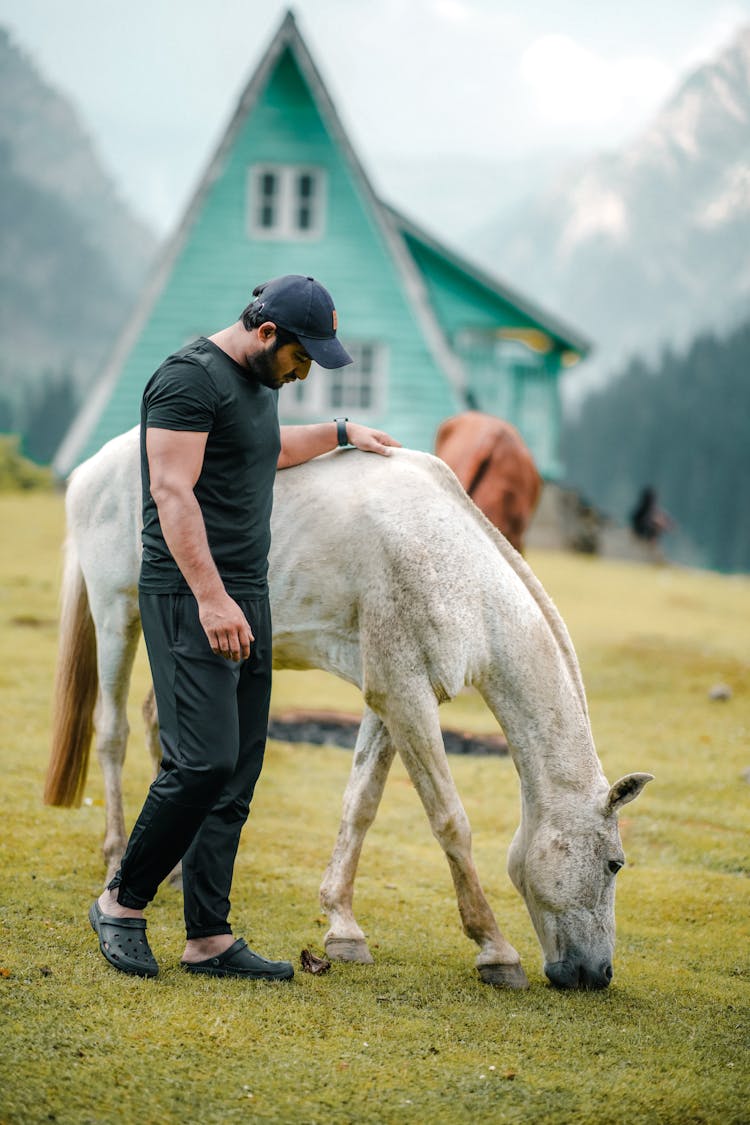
[{"left": 109, "top": 594, "right": 271, "bottom": 938}]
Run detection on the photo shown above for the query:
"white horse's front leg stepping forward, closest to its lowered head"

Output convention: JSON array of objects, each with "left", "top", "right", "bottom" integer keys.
[{"left": 387, "top": 684, "right": 528, "bottom": 989}]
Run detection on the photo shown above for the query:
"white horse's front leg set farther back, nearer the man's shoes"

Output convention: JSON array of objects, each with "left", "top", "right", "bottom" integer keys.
[{"left": 320, "top": 708, "right": 395, "bottom": 964}]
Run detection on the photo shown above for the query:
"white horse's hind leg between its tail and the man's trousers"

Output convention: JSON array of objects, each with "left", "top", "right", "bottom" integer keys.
[{"left": 93, "top": 599, "right": 141, "bottom": 882}]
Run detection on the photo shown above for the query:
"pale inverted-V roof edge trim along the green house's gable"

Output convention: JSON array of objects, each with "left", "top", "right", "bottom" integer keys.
[{"left": 53, "top": 11, "right": 466, "bottom": 476}]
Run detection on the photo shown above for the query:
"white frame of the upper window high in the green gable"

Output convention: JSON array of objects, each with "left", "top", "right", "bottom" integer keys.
[{"left": 247, "top": 163, "right": 327, "bottom": 242}]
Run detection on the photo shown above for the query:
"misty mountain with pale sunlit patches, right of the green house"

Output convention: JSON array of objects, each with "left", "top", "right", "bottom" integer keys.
[{"left": 471, "top": 27, "right": 750, "bottom": 405}]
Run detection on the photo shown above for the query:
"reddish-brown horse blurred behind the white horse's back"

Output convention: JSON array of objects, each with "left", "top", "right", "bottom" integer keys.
[{"left": 435, "top": 411, "right": 542, "bottom": 551}]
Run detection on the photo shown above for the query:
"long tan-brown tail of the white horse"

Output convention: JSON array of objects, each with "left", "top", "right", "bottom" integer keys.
[{"left": 44, "top": 538, "right": 99, "bottom": 809}]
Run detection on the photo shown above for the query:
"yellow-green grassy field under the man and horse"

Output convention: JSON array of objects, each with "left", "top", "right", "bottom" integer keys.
[{"left": 0, "top": 494, "right": 750, "bottom": 1125}]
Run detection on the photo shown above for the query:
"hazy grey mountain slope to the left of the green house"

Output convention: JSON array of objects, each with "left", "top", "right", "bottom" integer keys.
[{"left": 0, "top": 28, "right": 155, "bottom": 402}]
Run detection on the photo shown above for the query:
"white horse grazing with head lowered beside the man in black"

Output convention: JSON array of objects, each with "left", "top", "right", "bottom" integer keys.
[{"left": 45, "top": 429, "right": 651, "bottom": 988}]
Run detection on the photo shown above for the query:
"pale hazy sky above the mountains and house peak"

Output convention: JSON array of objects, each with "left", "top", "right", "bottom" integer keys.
[{"left": 0, "top": 0, "right": 750, "bottom": 233}]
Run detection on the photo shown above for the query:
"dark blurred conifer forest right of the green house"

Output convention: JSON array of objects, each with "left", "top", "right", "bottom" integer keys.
[{"left": 562, "top": 321, "right": 750, "bottom": 572}]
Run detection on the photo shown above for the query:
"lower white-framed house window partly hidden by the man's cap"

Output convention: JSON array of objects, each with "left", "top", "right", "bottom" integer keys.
[{"left": 279, "top": 340, "right": 388, "bottom": 422}]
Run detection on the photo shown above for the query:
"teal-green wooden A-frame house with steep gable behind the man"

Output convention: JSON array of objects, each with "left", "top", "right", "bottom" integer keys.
[{"left": 54, "top": 12, "right": 588, "bottom": 478}]
